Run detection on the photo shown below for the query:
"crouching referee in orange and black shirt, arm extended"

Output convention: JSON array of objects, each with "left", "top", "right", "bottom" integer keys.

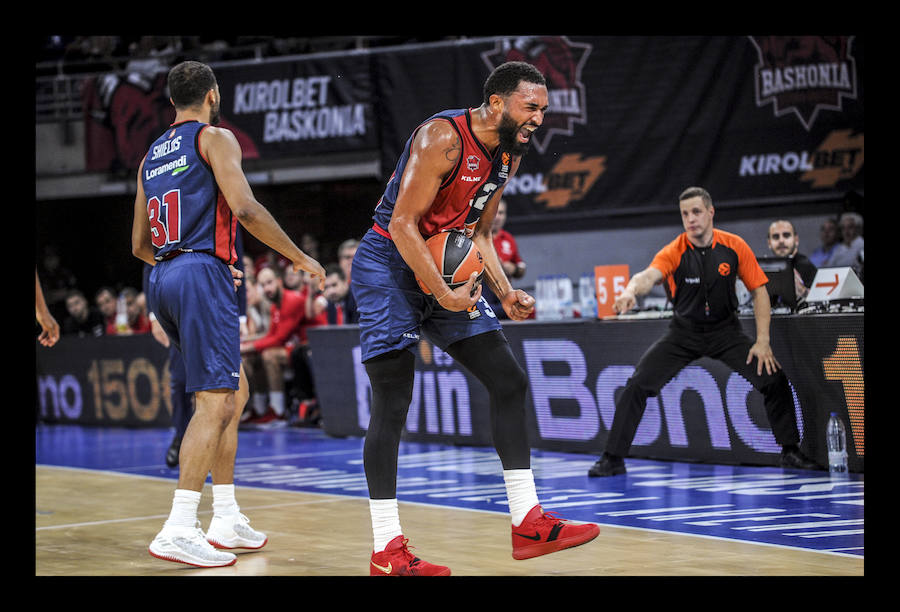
[{"left": 588, "top": 187, "right": 821, "bottom": 476}]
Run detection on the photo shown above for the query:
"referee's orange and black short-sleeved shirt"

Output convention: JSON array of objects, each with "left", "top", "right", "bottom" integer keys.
[{"left": 650, "top": 229, "right": 769, "bottom": 323}]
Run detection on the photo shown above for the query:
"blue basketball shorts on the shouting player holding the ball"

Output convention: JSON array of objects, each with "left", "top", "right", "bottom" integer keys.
[{"left": 350, "top": 229, "right": 502, "bottom": 361}]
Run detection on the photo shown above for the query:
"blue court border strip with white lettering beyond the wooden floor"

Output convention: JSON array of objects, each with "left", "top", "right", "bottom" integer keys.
[{"left": 35, "top": 425, "right": 865, "bottom": 557}]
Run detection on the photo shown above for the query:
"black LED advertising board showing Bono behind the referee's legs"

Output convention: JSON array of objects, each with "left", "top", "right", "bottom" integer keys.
[{"left": 309, "top": 315, "right": 865, "bottom": 471}]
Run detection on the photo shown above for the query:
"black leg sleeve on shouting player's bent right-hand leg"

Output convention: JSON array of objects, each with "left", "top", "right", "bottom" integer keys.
[{"left": 447, "top": 332, "right": 531, "bottom": 470}]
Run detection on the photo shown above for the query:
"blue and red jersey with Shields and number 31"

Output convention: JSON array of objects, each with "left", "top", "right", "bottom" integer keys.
[{"left": 141, "top": 121, "right": 237, "bottom": 264}]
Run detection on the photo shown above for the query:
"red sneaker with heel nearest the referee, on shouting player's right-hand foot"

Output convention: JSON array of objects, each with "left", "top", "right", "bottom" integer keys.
[{"left": 512, "top": 505, "right": 600, "bottom": 559}]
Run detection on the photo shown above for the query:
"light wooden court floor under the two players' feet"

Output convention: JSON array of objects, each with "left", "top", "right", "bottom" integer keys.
[{"left": 35, "top": 465, "right": 864, "bottom": 577}]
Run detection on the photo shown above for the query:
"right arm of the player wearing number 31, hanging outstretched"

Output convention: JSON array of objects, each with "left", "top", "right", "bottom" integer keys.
[{"left": 200, "top": 128, "right": 325, "bottom": 289}]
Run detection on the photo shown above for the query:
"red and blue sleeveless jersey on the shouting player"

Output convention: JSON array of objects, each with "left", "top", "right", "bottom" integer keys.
[{"left": 373, "top": 109, "right": 512, "bottom": 239}]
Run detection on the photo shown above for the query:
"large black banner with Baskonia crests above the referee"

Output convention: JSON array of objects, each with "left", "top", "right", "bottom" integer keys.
[{"left": 376, "top": 36, "right": 864, "bottom": 219}]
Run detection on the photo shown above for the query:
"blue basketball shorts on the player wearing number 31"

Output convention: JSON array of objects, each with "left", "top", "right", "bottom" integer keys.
[{"left": 147, "top": 253, "right": 241, "bottom": 393}]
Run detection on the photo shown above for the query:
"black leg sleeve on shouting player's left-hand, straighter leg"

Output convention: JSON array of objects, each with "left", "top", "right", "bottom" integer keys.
[{"left": 363, "top": 350, "right": 415, "bottom": 499}]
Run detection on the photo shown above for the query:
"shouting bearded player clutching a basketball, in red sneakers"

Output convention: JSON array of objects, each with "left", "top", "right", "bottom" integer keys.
[{"left": 351, "top": 62, "right": 599, "bottom": 576}]
